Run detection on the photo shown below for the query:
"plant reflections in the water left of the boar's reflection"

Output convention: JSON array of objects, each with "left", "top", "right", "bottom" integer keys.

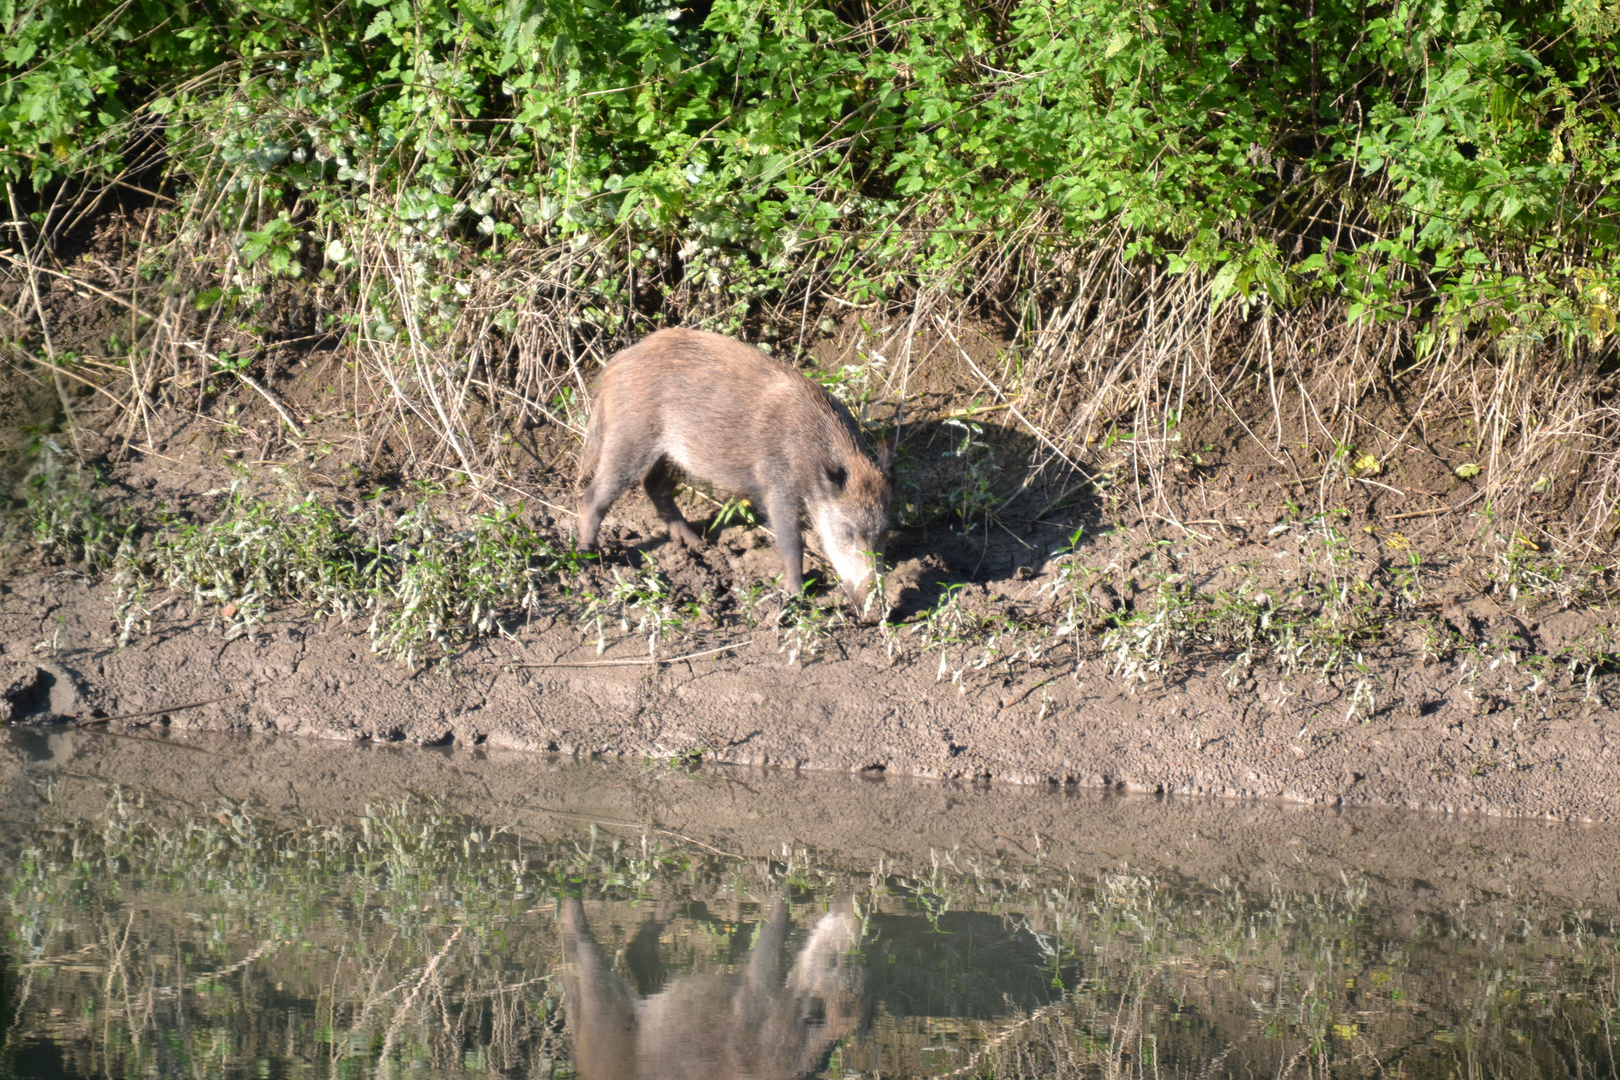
[{"left": 8, "top": 793, "right": 567, "bottom": 1075}]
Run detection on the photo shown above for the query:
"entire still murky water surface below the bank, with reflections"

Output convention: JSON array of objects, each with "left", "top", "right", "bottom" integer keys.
[{"left": 0, "top": 730, "right": 1620, "bottom": 1080}]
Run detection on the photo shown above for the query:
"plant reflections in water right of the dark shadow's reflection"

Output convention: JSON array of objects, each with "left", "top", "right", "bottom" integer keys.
[{"left": 946, "top": 874, "right": 1620, "bottom": 1077}]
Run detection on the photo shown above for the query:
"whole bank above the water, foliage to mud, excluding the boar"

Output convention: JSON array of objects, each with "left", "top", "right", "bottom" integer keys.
[{"left": 0, "top": 0, "right": 1620, "bottom": 819}]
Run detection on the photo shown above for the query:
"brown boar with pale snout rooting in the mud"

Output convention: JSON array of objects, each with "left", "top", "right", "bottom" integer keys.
[{"left": 580, "top": 330, "right": 893, "bottom": 609}]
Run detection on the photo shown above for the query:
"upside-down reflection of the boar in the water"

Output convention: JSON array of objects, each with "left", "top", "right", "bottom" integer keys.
[{"left": 559, "top": 897, "right": 867, "bottom": 1080}]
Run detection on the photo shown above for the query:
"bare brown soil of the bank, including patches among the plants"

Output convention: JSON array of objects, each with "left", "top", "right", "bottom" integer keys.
[{"left": 0, "top": 210, "right": 1620, "bottom": 821}]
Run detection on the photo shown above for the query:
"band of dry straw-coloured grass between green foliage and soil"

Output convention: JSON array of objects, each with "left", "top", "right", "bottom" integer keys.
[{"left": 9, "top": 175, "right": 1620, "bottom": 551}]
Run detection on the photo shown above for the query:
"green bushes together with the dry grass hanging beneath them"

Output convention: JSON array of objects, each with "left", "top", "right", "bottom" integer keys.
[{"left": 0, "top": 0, "right": 1620, "bottom": 547}]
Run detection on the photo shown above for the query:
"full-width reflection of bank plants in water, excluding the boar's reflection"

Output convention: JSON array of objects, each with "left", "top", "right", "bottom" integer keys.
[{"left": 0, "top": 792, "right": 1620, "bottom": 1077}]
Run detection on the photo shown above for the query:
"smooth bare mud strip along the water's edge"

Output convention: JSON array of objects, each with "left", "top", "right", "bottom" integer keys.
[{"left": 12, "top": 544, "right": 1620, "bottom": 821}]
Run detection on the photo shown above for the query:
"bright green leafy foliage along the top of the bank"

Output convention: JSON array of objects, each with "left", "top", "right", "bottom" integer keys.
[{"left": 0, "top": 0, "right": 1620, "bottom": 345}]
